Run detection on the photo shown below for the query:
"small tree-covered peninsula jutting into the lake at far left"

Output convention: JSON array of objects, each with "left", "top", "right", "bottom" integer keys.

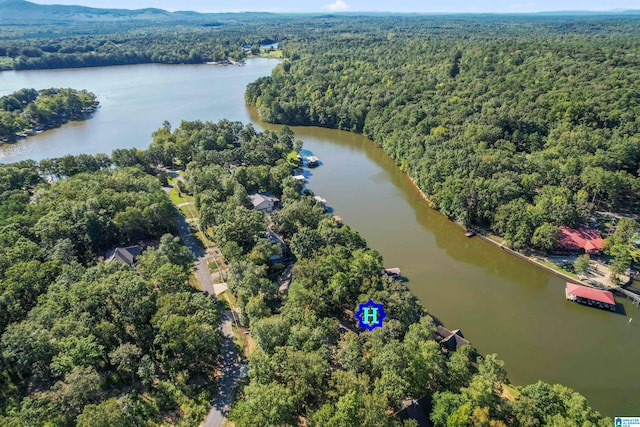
[{"left": 0, "top": 88, "right": 99, "bottom": 143}]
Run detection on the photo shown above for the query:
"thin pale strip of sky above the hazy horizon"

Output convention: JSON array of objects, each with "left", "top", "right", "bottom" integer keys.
[{"left": 31, "top": 0, "right": 640, "bottom": 13}]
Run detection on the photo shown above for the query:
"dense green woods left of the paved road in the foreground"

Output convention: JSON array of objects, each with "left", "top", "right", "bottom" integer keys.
[{"left": 0, "top": 160, "right": 220, "bottom": 426}]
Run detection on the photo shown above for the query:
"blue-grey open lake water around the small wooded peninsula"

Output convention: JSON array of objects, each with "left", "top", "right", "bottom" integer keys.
[{"left": 0, "top": 59, "right": 277, "bottom": 163}]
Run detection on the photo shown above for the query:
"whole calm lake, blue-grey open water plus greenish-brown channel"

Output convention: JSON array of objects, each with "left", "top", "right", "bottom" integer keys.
[{"left": 0, "top": 60, "right": 640, "bottom": 416}]
